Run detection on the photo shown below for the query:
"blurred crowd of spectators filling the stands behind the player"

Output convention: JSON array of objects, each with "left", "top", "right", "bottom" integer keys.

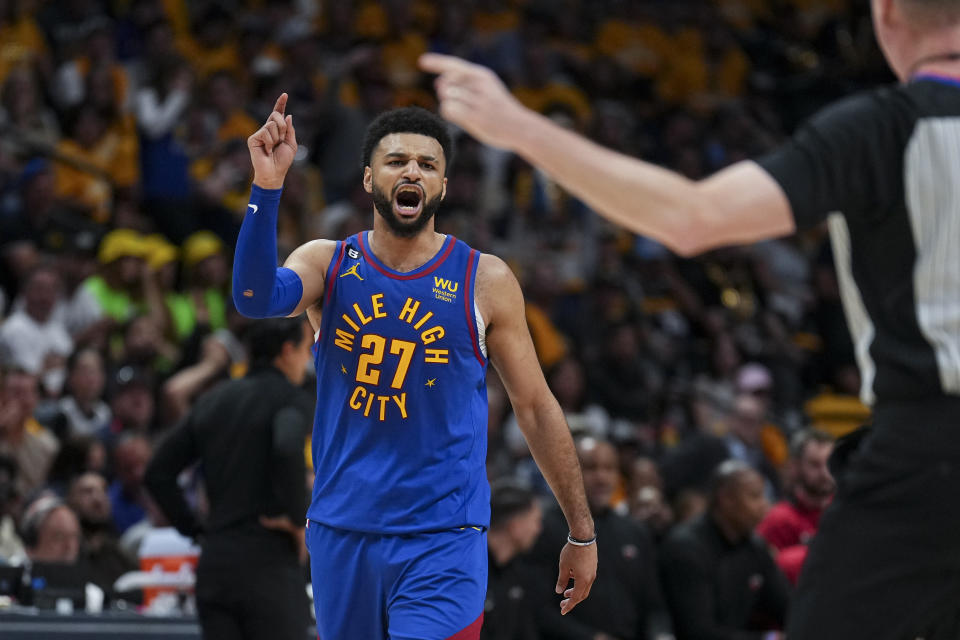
[{"left": 0, "top": 0, "right": 889, "bottom": 637}]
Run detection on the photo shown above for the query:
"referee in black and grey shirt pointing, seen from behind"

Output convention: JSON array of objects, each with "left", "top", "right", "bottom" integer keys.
[{"left": 420, "top": 0, "right": 960, "bottom": 640}]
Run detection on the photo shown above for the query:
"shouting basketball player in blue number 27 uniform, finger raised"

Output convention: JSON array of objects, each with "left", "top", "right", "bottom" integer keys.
[{"left": 233, "top": 94, "right": 597, "bottom": 640}]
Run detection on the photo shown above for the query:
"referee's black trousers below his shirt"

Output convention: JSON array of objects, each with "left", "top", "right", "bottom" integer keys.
[{"left": 787, "top": 397, "right": 960, "bottom": 640}]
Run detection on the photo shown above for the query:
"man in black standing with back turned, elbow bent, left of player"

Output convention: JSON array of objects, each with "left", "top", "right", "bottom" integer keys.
[{"left": 145, "top": 317, "right": 313, "bottom": 640}]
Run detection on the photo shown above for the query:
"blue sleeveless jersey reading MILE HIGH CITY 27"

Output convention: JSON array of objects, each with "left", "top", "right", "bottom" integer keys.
[{"left": 307, "top": 231, "right": 490, "bottom": 534}]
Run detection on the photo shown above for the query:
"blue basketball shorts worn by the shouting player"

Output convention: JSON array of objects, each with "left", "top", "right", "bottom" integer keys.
[{"left": 306, "top": 520, "right": 487, "bottom": 640}]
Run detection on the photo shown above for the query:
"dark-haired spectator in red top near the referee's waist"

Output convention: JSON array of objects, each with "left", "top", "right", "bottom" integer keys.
[{"left": 757, "top": 429, "right": 836, "bottom": 584}]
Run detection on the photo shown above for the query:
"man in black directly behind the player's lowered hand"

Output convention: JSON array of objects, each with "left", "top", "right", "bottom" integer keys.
[{"left": 533, "top": 437, "right": 672, "bottom": 640}]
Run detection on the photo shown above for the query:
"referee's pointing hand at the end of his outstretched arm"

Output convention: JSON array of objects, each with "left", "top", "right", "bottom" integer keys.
[{"left": 419, "top": 53, "right": 533, "bottom": 149}]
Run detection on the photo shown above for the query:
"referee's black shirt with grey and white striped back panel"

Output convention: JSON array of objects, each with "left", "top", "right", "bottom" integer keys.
[{"left": 759, "top": 76, "right": 960, "bottom": 404}]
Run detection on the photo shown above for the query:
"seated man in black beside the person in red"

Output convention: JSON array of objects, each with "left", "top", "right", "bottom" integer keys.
[{"left": 660, "top": 460, "right": 788, "bottom": 640}]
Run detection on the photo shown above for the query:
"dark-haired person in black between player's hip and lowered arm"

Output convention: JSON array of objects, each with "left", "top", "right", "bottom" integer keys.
[{"left": 480, "top": 482, "right": 543, "bottom": 640}]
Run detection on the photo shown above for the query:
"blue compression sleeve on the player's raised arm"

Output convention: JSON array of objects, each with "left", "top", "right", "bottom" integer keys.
[{"left": 233, "top": 185, "right": 303, "bottom": 318}]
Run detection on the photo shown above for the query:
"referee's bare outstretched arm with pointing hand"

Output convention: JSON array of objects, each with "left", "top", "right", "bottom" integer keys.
[{"left": 420, "top": 54, "right": 794, "bottom": 255}]
